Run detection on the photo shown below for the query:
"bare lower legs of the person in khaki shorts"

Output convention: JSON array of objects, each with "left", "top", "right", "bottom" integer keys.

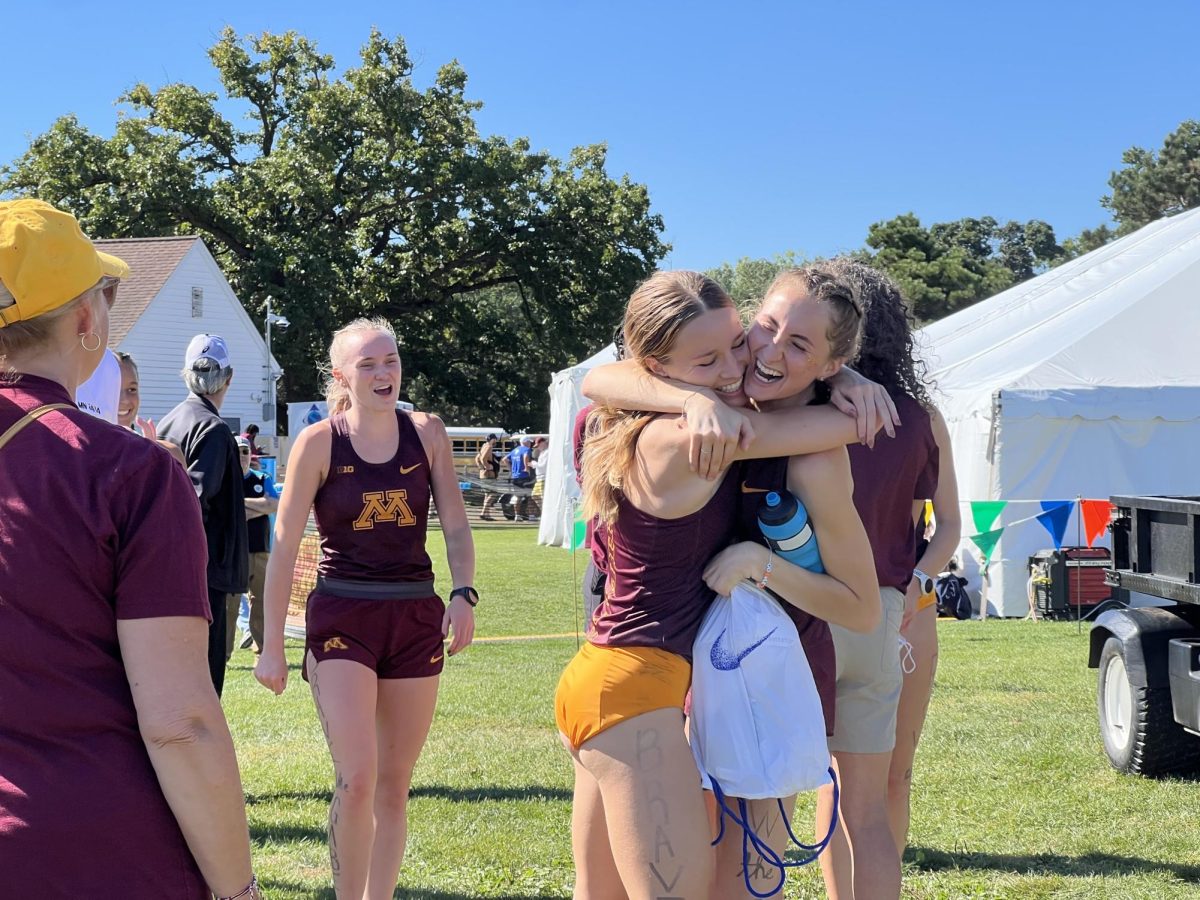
[{"left": 818, "top": 752, "right": 900, "bottom": 900}]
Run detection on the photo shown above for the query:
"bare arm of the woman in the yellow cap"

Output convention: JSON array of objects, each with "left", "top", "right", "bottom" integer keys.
[{"left": 116, "top": 616, "right": 251, "bottom": 896}]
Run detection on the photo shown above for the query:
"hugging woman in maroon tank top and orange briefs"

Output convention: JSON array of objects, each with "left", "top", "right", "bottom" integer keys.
[{"left": 554, "top": 272, "right": 878, "bottom": 898}]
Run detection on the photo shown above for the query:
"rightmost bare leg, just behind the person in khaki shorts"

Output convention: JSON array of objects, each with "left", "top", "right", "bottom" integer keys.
[{"left": 888, "top": 606, "right": 937, "bottom": 859}]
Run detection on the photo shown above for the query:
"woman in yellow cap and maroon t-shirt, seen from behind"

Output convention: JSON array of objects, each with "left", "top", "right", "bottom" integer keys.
[{"left": 0, "top": 199, "right": 258, "bottom": 900}]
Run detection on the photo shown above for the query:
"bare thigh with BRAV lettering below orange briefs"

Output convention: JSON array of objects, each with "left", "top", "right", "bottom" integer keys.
[{"left": 576, "top": 709, "right": 713, "bottom": 900}]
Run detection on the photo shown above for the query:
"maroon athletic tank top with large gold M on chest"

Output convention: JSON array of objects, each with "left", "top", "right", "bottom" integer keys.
[{"left": 313, "top": 410, "right": 433, "bottom": 582}]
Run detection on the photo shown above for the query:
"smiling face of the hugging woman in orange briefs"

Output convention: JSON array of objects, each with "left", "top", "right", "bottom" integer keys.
[{"left": 646, "top": 306, "right": 748, "bottom": 406}]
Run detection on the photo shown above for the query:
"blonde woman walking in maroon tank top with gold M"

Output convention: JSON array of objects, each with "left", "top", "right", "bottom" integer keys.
[{"left": 254, "top": 319, "right": 479, "bottom": 900}]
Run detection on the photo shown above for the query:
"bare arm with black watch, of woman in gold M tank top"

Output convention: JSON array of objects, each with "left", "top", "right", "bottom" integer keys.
[{"left": 413, "top": 413, "right": 475, "bottom": 656}]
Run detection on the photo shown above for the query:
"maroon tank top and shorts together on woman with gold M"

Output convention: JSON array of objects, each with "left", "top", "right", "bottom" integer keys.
[{"left": 304, "top": 410, "right": 445, "bottom": 679}]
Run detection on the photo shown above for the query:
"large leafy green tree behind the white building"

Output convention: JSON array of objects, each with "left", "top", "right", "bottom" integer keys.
[{"left": 0, "top": 29, "right": 668, "bottom": 427}]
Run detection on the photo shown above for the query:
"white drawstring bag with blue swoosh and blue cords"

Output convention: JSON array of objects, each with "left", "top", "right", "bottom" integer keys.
[{"left": 689, "top": 582, "right": 838, "bottom": 896}]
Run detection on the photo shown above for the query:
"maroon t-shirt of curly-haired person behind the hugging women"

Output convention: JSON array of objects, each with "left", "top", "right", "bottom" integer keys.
[{"left": 847, "top": 394, "right": 953, "bottom": 590}]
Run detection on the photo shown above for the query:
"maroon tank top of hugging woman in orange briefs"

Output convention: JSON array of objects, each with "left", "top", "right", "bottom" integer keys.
[{"left": 588, "top": 466, "right": 739, "bottom": 661}]
